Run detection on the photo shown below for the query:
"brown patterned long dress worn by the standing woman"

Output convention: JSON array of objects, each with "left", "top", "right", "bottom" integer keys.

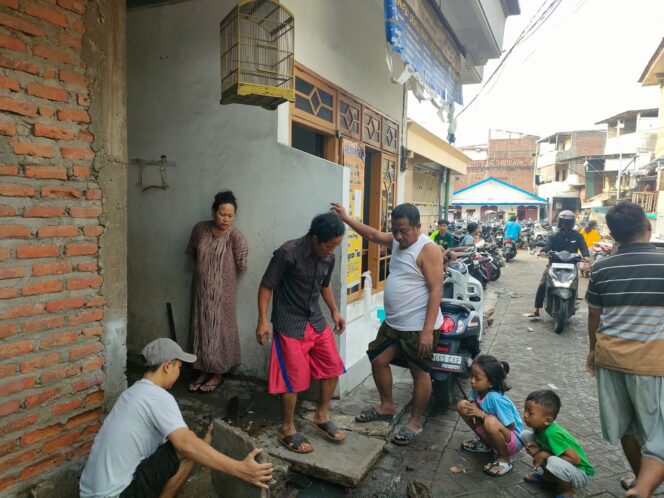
[{"left": 186, "top": 221, "right": 247, "bottom": 374}]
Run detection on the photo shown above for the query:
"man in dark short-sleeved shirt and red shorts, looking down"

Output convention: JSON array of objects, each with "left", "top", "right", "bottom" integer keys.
[{"left": 256, "top": 213, "right": 346, "bottom": 453}]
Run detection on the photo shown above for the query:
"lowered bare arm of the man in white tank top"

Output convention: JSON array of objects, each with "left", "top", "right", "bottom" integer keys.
[{"left": 419, "top": 244, "right": 443, "bottom": 358}]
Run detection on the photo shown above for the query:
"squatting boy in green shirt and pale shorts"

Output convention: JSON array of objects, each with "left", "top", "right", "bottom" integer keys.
[{"left": 520, "top": 390, "right": 595, "bottom": 497}]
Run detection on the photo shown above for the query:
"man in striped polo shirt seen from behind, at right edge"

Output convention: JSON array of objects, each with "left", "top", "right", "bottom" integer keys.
[{"left": 587, "top": 202, "right": 664, "bottom": 498}]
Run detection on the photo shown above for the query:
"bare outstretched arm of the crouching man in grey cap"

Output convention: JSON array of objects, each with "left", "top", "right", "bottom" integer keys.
[{"left": 168, "top": 427, "right": 272, "bottom": 489}]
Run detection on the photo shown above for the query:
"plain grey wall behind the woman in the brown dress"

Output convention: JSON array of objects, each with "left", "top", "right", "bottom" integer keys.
[{"left": 127, "top": 0, "right": 345, "bottom": 377}]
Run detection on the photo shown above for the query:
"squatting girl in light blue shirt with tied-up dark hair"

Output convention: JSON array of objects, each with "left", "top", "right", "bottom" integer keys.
[{"left": 457, "top": 355, "right": 523, "bottom": 477}]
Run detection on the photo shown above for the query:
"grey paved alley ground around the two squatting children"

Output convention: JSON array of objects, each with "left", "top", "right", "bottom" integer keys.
[{"left": 349, "top": 251, "right": 664, "bottom": 498}]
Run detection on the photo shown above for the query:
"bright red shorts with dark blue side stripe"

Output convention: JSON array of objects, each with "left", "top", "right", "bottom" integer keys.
[{"left": 267, "top": 323, "right": 346, "bottom": 394}]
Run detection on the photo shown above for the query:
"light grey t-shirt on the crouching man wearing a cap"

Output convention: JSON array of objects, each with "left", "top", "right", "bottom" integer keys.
[{"left": 80, "top": 379, "right": 187, "bottom": 498}]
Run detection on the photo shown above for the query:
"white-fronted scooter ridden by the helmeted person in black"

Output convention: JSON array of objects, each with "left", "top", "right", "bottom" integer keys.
[{"left": 544, "top": 251, "right": 583, "bottom": 334}]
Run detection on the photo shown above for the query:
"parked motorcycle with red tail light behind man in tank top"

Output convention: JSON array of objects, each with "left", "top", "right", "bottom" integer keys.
[{"left": 431, "top": 261, "right": 484, "bottom": 407}]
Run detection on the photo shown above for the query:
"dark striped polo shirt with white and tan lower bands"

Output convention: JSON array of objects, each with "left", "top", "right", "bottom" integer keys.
[{"left": 586, "top": 242, "right": 664, "bottom": 376}]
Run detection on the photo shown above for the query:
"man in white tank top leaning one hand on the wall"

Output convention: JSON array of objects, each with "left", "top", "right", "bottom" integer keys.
[{"left": 332, "top": 203, "right": 443, "bottom": 445}]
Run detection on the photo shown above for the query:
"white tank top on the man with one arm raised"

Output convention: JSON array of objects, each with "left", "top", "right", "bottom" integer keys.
[{"left": 383, "top": 235, "right": 443, "bottom": 332}]
